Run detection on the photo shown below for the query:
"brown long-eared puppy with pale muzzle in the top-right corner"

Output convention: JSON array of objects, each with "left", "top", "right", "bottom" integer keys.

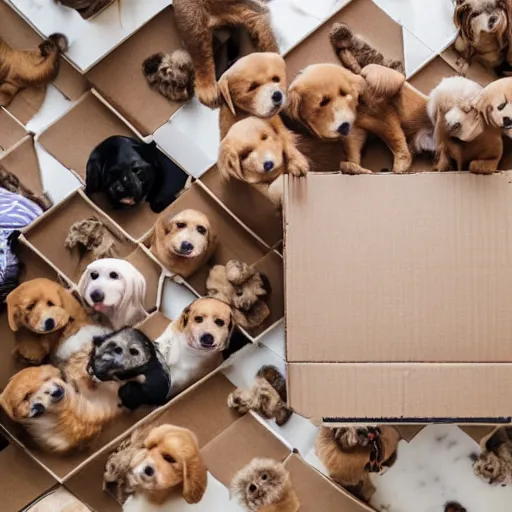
[{"left": 453, "top": 0, "right": 512, "bottom": 68}]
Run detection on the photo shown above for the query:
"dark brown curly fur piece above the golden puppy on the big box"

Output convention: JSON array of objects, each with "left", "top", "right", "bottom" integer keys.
[{"left": 329, "top": 23, "right": 405, "bottom": 75}]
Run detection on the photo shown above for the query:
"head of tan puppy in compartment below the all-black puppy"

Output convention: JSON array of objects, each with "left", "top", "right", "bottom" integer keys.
[{"left": 155, "top": 210, "right": 215, "bottom": 258}]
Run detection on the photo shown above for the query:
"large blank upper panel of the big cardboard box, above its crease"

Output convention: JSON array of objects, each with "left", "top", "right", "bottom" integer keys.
[{"left": 286, "top": 173, "right": 512, "bottom": 363}]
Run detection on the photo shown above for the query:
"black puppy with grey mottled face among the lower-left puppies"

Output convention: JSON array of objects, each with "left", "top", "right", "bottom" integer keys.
[{"left": 87, "top": 327, "right": 171, "bottom": 410}]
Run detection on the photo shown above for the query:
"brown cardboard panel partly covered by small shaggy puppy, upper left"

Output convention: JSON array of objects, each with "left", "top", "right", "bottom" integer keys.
[{"left": 87, "top": 7, "right": 182, "bottom": 136}]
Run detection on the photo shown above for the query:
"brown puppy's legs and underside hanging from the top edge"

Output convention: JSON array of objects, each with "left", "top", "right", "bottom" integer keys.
[{"left": 173, "top": 0, "right": 279, "bottom": 108}]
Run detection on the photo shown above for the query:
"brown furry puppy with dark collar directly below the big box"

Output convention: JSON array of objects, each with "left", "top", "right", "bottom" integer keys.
[{"left": 315, "top": 426, "right": 400, "bottom": 502}]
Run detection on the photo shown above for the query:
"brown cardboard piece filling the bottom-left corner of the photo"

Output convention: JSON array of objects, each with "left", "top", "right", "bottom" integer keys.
[{"left": 0, "top": 430, "right": 57, "bottom": 512}]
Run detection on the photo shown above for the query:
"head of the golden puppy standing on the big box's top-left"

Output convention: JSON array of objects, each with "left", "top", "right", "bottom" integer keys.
[{"left": 288, "top": 64, "right": 366, "bottom": 139}]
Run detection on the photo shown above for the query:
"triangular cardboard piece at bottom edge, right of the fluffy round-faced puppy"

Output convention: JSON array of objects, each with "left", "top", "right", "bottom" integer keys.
[{"left": 285, "top": 454, "right": 373, "bottom": 512}]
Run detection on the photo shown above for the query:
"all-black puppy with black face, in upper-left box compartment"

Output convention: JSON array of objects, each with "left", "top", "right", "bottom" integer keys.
[{"left": 85, "top": 135, "right": 187, "bottom": 213}]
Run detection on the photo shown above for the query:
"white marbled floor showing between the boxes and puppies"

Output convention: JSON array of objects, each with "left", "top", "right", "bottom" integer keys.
[{"left": 11, "top": 0, "right": 512, "bottom": 512}]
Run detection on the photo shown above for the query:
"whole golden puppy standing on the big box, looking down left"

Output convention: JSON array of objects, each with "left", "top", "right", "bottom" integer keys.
[{"left": 287, "top": 64, "right": 434, "bottom": 174}]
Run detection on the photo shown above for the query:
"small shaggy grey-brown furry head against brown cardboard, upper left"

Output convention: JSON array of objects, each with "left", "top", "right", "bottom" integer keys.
[{"left": 142, "top": 50, "right": 194, "bottom": 102}]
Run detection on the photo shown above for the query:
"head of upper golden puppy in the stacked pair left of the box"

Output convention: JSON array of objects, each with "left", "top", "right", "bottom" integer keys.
[{"left": 219, "top": 52, "right": 287, "bottom": 117}]
